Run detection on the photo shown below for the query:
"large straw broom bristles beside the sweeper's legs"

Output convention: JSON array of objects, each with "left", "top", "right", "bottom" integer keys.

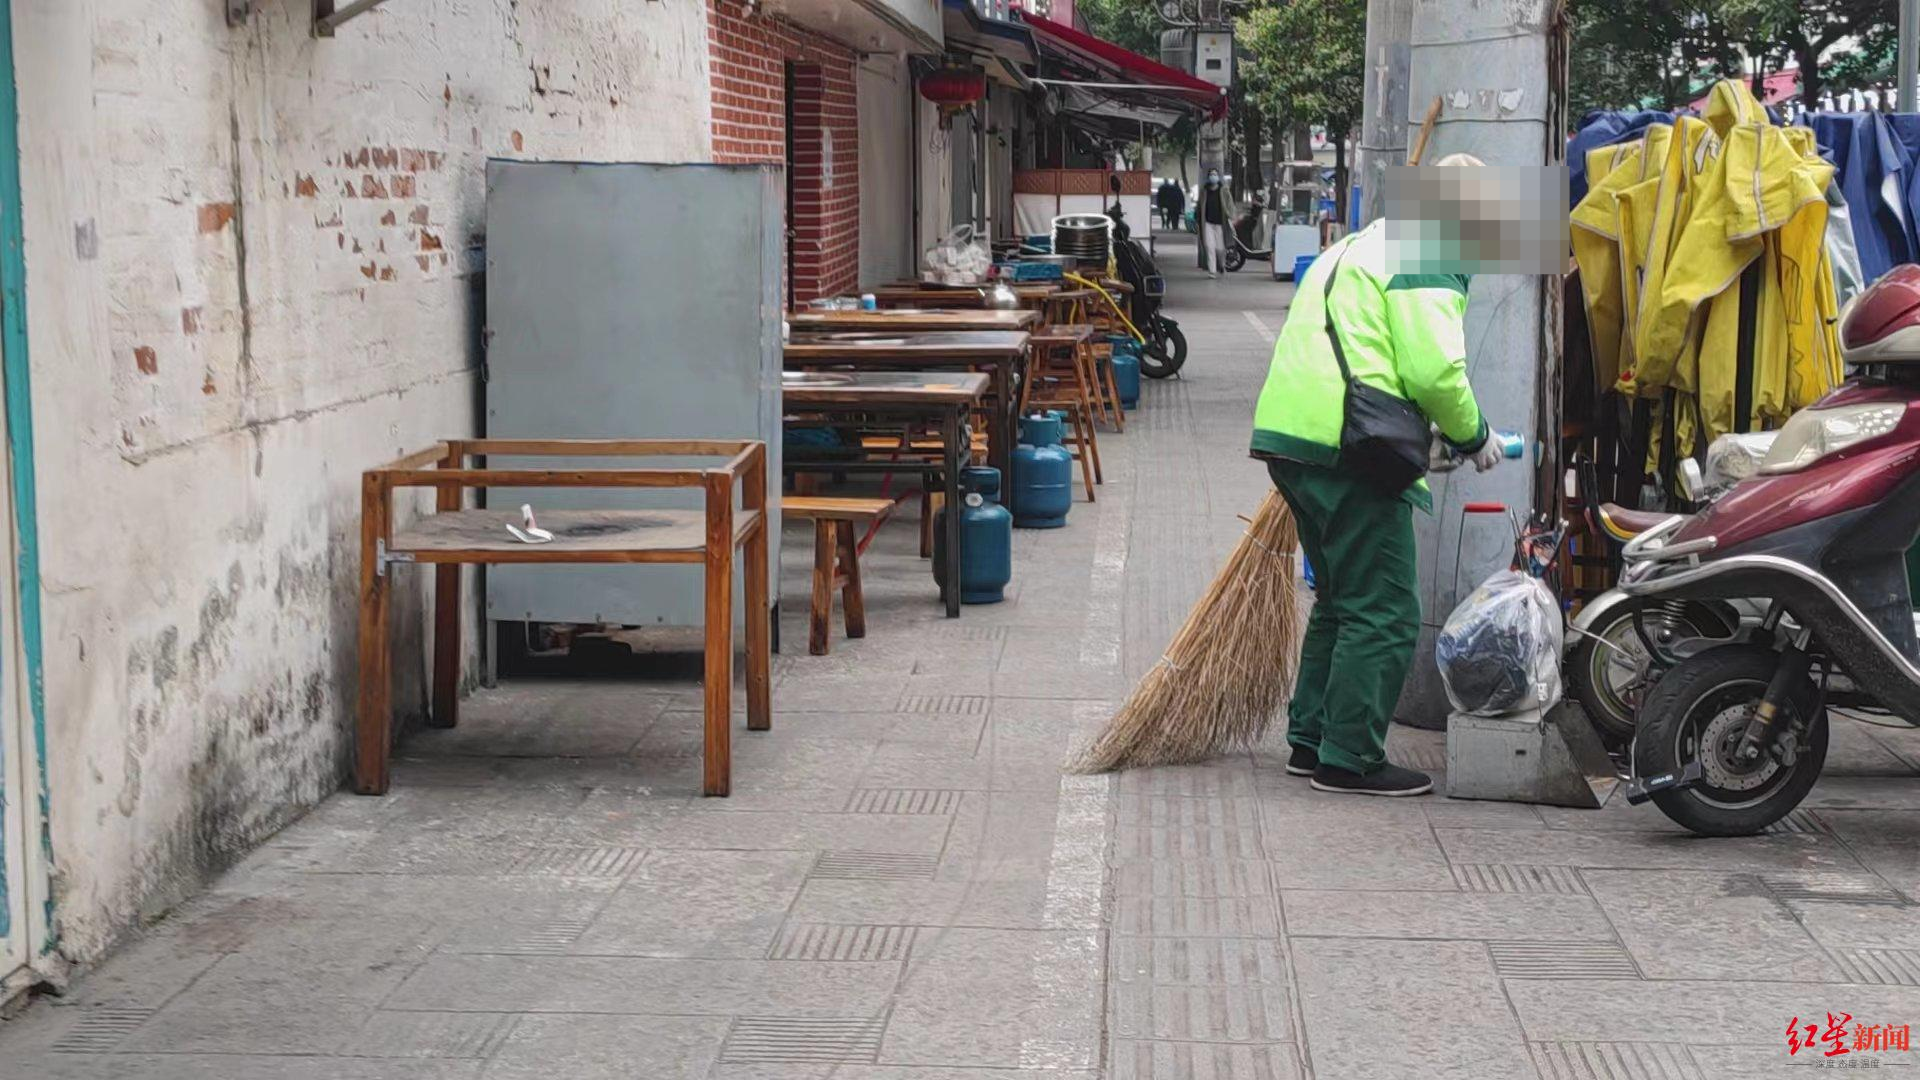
[{"left": 1069, "top": 492, "right": 1300, "bottom": 773}]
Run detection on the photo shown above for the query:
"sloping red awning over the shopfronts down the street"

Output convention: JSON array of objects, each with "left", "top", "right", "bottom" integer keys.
[{"left": 1020, "top": 12, "right": 1227, "bottom": 127}]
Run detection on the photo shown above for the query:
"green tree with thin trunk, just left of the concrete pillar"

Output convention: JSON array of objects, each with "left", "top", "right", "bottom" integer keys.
[{"left": 1236, "top": 0, "right": 1367, "bottom": 219}]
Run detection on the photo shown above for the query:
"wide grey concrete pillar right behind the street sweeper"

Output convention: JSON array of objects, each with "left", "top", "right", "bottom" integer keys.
[{"left": 1396, "top": 0, "right": 1561, "bottom": 728}]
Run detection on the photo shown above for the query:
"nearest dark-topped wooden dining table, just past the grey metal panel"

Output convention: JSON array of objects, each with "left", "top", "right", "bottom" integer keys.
[{"left": 781, "top": 368, "right": 990, "bottom": 619}]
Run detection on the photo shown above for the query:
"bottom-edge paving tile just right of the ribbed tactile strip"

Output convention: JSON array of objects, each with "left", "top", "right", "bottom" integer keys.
[{"left": 1292, "top": 938, "right": 1536, "bottom": 1080}]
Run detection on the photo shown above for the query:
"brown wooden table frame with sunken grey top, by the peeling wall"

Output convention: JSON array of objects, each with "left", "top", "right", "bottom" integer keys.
[{"left": 353, "top": 432, "right": 768, "bottom": 796}]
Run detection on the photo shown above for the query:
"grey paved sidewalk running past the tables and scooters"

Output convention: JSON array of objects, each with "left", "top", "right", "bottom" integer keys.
[{"left": 11, "top": 236, "right": 1920, "bottom": 1080}]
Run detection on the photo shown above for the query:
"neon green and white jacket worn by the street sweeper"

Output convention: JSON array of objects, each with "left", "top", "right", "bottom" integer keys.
[{"left": 1252, "top": 221, "right": 1488, "bottom": 507}]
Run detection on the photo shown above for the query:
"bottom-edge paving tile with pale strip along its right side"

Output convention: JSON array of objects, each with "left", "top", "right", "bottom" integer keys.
[{"left": 879, "top": 930, "right": 1102, "bottom": 1068}]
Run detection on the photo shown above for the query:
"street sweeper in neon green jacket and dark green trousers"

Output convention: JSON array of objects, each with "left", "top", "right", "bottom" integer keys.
[{"left": 1252, "top": 154, "right": 1501, "bottom": 796}]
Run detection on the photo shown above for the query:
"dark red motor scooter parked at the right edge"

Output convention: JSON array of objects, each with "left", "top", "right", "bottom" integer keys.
[{"left": 1620, "top": 265, "right": 1920, "bottom": 836}]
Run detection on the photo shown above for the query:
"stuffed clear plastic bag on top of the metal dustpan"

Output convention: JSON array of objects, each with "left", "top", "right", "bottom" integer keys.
[{"left": 1434, "top": 569, "right": 1563, "bottom": 717}]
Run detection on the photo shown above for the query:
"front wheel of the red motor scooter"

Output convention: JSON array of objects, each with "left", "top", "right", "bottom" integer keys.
[{"left": 1634, "top": 646, "right": 1828, "bottom": 836}]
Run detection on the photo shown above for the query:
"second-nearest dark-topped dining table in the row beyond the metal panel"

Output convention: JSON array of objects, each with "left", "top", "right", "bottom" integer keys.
[{"left": 785, "top": 328, "right": 1035, "bottom": 484}]
